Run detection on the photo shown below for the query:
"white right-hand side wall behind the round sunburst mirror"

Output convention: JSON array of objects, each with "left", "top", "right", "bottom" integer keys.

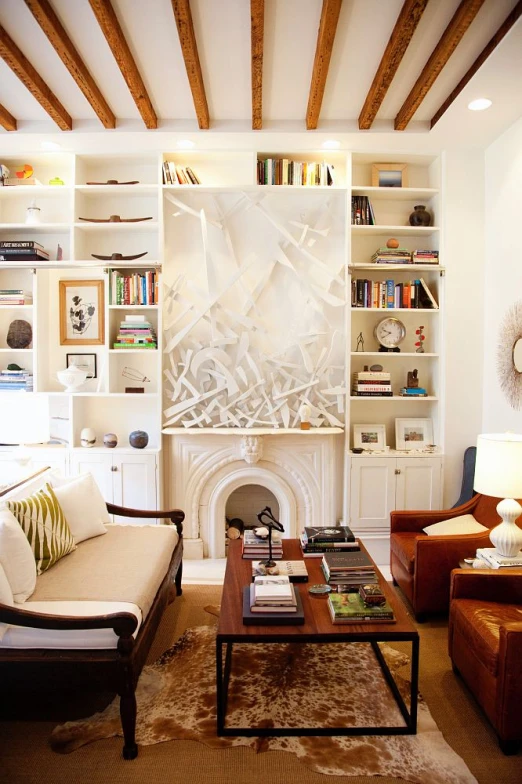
[{"left": 482, "top": 119, "right": 522, "bottom": 433}]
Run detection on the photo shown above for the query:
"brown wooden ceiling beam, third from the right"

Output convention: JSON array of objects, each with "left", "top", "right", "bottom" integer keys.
[{"left": 359, "top": 0, "right": 428, "bottom": 131}]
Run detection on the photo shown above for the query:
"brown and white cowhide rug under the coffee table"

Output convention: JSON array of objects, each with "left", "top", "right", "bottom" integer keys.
[{"left": 50, "top": 626, "right": 476, "bottom": 784}]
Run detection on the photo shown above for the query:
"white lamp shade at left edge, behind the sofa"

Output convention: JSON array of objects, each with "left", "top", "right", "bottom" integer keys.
[{"left": 0, "top": 392, "right": 50, "bottom": 444}]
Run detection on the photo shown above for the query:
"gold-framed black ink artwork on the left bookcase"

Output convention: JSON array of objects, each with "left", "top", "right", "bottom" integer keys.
[{"left": 60, "top": 280, "right": 105, "bottom": 346}]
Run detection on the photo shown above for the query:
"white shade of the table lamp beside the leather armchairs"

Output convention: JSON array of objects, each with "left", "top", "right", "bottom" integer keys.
[{"left": 473, "top": 433, "right": 522, "bottom": 498}]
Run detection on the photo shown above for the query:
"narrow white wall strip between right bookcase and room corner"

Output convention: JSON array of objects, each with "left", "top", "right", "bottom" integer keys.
[{"left": 441, "top": 149, "right": 485, "bottom": 508}]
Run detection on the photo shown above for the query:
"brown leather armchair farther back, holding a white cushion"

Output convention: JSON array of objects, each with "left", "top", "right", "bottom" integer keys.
[{"left": 390, "top": 494, "right": 520, "bottom": 621}]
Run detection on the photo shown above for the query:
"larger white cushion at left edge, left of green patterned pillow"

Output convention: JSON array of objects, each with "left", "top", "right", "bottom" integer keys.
[{"left": 0, "top": 509, "right": 36, "bottom": 602}]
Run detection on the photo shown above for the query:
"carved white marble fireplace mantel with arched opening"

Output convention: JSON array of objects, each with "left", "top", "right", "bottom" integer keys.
[{"left": 163, "top": 427, "right": 344, "bottom": 558}]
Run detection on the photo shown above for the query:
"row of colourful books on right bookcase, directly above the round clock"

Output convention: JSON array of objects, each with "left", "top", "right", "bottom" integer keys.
[{"left": 351, "top": 278, "right": 439, "bottom": 310}]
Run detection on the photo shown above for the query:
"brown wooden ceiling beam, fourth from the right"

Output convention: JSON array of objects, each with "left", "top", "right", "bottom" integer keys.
[{"left": 306, "top": 0, "right": 343, "bottom": 131}]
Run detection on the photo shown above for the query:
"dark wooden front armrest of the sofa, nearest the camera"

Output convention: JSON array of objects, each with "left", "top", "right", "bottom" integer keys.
[{"left": 0, "top": 603, "right": 138, "bottom": 638}]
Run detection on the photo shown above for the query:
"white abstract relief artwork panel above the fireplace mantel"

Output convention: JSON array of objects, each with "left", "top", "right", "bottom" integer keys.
[{"left": 164, "top": 189, "right": 346, "bottom": 428}]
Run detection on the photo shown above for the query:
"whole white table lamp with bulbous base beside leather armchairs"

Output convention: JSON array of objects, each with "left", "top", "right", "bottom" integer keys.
[{"left": 473, "top": 433, "right": 522, "bottom": 557}]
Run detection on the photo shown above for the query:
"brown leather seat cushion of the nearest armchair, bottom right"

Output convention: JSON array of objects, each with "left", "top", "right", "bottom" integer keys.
[{"left": 451, "top": 599, "right": 522, "bottom": 677}]
